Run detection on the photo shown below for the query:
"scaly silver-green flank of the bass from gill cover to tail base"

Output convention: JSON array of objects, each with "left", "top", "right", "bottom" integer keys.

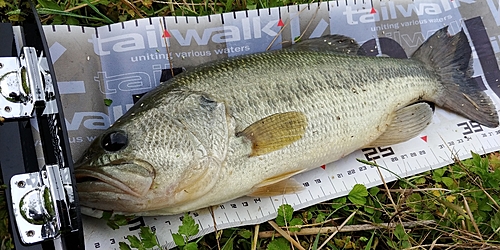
[{"left": 120, "top": 51, "right": 438, "bottom": 213}]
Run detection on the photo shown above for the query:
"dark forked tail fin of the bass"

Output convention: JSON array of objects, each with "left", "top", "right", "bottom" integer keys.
[{"left": 411, "top": 27, "right": 499, "bottom": 128}]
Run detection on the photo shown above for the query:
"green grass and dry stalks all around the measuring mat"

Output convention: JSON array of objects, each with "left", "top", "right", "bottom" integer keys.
[{"left": 0, "top": 0, "right": 500, "bottom": 250}]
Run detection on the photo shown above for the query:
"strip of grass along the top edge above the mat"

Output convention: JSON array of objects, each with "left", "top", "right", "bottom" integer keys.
[{"left": 0, "top": 0, "right": 312, "bottom": 26}]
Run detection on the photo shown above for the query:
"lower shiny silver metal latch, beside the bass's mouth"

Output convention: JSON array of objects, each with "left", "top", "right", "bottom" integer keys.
[{"left": 10, "top": 165, "right": 78, "bottom": 244}]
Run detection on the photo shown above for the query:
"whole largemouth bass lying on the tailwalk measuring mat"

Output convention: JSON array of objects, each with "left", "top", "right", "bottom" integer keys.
[{"left": 75, "top": 28, "right": 499, "bottom": 215}]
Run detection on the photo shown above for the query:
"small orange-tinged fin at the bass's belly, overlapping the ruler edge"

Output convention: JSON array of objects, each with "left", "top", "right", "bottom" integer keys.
[{"left": 248, "top": 170, "right": 304, "bottom": 197}]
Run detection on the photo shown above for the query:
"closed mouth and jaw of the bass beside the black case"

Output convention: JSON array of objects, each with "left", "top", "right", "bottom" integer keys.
[{"left": 75, "top": 161, "right": 155, "bottom": 197}]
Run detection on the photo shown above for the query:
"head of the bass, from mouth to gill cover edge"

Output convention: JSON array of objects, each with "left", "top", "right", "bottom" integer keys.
[{"left": 75, "top": 89, "right": 228, "bottom": 214}]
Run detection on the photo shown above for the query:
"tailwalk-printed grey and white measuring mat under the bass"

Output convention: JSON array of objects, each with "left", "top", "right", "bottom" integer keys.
[{"left": 39, "top": 0, "right": 500, "bottom": 249}]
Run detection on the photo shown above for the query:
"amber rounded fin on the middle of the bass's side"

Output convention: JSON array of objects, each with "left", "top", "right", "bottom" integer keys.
[{"left": 236, "top": 112, "right": 307, "bottom": 157}]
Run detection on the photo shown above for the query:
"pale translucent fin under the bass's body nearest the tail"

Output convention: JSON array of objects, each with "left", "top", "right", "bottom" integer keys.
[{"left": 368, "top": 102, "right": 433, "bottom": 147}]
